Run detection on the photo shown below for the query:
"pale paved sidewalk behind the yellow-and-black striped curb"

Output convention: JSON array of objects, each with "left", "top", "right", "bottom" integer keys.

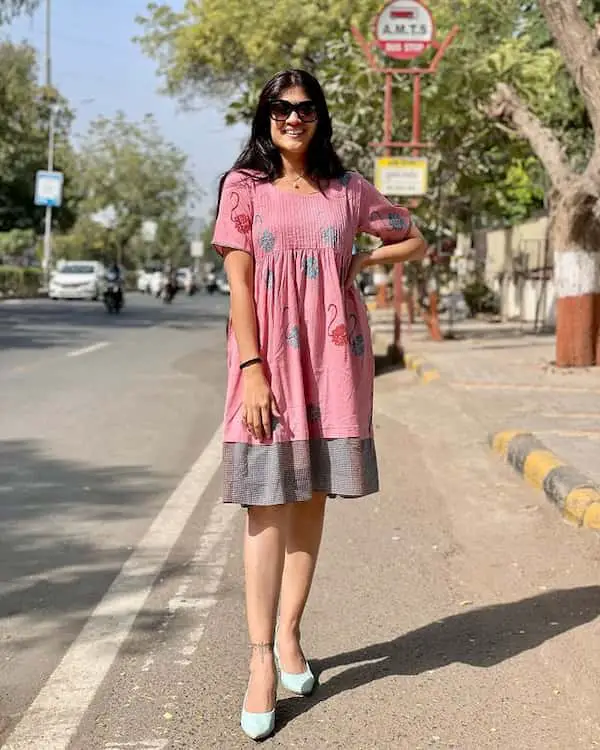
[{"left": 371, "top": 311, "right": 600, "bottom": 484}]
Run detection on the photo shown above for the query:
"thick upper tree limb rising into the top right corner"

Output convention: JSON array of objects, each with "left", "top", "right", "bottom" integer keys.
[{"left": 540, "top": 0, "right": 600, "bottom": 139}]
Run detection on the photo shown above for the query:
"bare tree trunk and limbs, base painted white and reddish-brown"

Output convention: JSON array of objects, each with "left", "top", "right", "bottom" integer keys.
[{"left": 488, "top": 0, "right": 600, "bottom": 366}]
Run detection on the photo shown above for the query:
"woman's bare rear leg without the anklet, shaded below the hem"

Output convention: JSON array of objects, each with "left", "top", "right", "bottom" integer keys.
[{"left": 277, "top": 493, "right": 326, "bottom": 674}]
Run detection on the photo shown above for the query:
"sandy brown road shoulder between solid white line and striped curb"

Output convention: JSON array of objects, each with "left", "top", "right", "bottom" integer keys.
[{"left": 85, "top": 362, "right": 600, "bottom": 750}]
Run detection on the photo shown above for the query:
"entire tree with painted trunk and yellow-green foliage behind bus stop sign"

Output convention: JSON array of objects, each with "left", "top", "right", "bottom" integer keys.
[{"left": 140, "top": 0, "right": 600, "bottom": 365}]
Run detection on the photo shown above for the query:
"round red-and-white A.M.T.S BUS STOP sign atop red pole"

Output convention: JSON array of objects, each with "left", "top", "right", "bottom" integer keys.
[{"left": 373, "top": 0, "right": 435, "bottom": 60}]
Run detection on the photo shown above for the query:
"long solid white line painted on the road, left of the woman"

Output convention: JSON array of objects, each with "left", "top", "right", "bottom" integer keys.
[{"left": 2, "top": 425, "right": 227, "bottom": 750}]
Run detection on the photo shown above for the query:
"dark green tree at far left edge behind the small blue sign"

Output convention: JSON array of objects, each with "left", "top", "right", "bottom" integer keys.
[{"left": 0, "top": 42, "right": 75, "bottom": 231}]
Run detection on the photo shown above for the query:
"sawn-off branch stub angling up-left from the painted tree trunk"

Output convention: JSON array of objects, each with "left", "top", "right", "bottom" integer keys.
[{"left": 485, "top": 83, "right": 575, "bottom": 192}]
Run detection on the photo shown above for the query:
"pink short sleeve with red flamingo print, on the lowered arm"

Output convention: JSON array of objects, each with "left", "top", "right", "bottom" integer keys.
[{"left": 212, "top": 172, "right": 254, "bottom": 255}]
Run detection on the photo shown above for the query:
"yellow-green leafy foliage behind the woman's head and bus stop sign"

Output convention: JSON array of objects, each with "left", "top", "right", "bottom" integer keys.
[{"left": 139, "top": 0, "right": 556, "bottom": 227}]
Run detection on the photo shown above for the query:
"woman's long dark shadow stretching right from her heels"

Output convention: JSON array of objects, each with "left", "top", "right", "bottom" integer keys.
[{"left": 277, "top": 586, "right": 600, "bottom": 729}]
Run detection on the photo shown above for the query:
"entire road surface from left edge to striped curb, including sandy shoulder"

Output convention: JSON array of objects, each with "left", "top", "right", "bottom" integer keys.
[{"left": 0, "top": 296, "right": 600, "bottom": 750}]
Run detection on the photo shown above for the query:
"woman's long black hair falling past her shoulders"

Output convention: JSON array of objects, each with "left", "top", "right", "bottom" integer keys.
[{"left": 219, "top": 68, "right": 346, "bottom": 206}]
